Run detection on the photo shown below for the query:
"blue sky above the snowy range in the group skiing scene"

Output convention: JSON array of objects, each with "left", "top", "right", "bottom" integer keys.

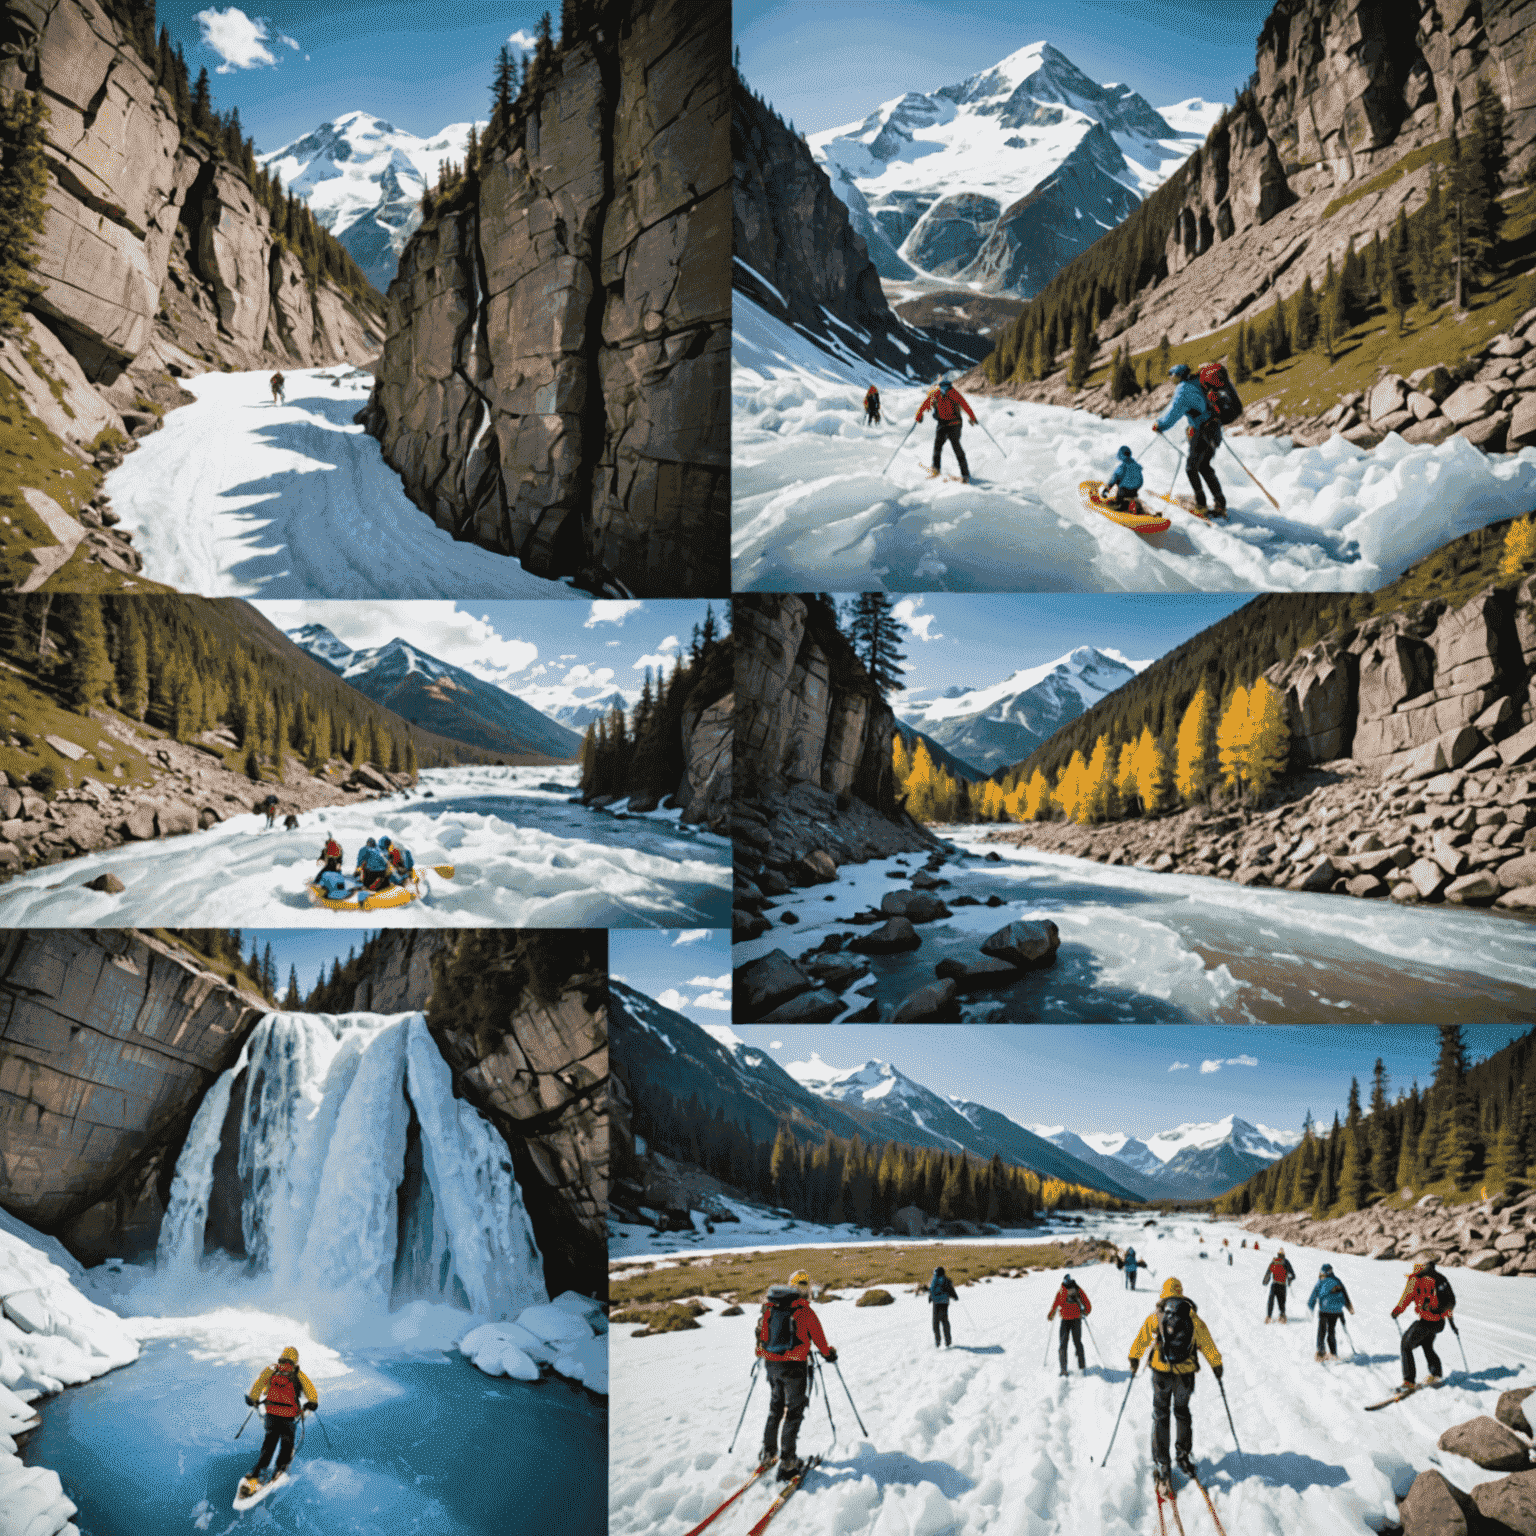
[{"left": 733, "top": 1025, "right": 1521, "bottom": 1137}]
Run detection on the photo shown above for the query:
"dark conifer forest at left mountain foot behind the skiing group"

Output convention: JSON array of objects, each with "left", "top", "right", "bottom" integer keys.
[{"left": 633, "top": 1084, "right": 1124, "bottom": 1229}]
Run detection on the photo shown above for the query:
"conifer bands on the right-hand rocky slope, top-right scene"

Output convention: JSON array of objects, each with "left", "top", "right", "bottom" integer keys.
[{"left": 983, "top": 78, "right": 1517, "bottom": 399}]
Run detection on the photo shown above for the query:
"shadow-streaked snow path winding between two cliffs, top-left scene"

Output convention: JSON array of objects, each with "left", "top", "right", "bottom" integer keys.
[{"left": 106, "top": 367, "right": 587, "bottom": 599}]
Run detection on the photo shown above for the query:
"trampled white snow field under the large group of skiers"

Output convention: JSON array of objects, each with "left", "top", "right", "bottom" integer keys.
[{"left": 608, "top": 1217, "right": 1536, "bottom": 1536}]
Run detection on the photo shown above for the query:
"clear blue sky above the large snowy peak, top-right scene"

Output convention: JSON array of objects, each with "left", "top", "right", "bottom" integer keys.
[{"left": 731, "top": 0, "right": 1272, "bottom": 134}]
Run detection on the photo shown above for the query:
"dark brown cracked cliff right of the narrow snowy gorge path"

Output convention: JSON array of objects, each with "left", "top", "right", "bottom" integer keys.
[{"left": 359, "top": 0, "right": 731, "bottom": 596}]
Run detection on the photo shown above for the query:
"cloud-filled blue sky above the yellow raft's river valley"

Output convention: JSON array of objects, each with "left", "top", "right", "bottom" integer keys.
[{"left": 252, "top": 598, "right": 727, "bottom": 711}]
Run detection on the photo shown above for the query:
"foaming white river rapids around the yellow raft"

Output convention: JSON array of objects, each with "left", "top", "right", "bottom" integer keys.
[{"left": 0, "top": 766, "right": 731, "bottom": 928}]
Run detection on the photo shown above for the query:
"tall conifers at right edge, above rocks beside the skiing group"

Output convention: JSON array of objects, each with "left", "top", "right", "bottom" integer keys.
[{"left": 1215, "top": 1025, "right": 1536, "bottom": 1220}]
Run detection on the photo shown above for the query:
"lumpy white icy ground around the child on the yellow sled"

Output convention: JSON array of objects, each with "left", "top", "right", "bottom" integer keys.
[{"left": 731, "top": 293, "right": 1536, "bottom": 591}]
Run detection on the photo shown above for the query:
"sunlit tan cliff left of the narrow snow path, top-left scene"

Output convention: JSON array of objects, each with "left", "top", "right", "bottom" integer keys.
[{"left": 0, "top": 0, "right": 381, "bottom": 442}]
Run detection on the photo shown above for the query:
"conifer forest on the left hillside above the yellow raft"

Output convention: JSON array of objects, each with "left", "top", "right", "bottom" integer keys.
[{"left": 0, "top": 594, "right": 516, "bottom": 780}]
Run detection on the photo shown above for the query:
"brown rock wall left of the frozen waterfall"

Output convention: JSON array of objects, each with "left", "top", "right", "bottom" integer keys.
[{"left": 0, "top": 929, "right": 264, "bottom": 1264}]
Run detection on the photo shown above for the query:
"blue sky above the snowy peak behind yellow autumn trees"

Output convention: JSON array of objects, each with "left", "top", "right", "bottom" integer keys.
[{"left": 884, "top": 593, "right": 1253, "bottom": 705}]
